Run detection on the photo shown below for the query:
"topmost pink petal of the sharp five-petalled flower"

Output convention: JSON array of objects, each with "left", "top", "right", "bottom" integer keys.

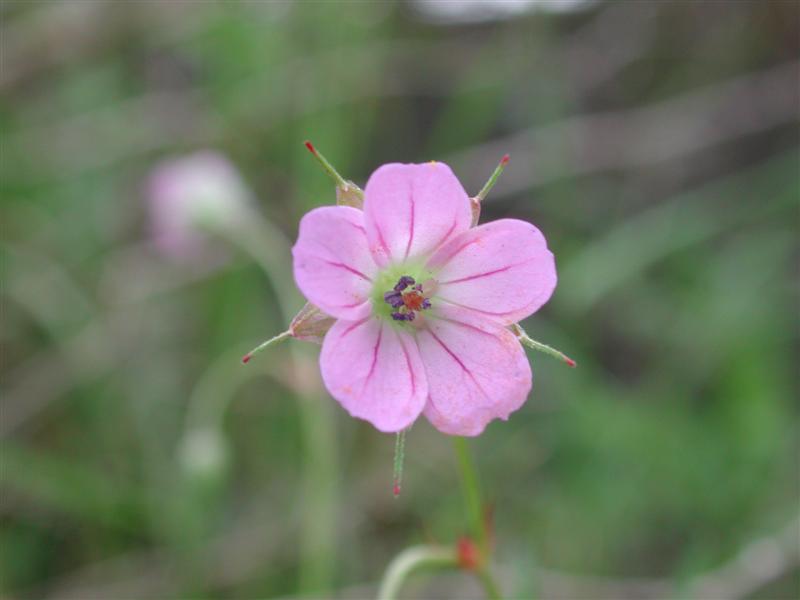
[{"left": 364, "top": 162, "right": 471, "bottom": 266}]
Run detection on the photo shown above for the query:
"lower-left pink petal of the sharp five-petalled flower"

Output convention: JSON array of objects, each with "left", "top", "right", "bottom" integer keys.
[{"left": 320, "top": 317, "right": 428, "bottom": 433}]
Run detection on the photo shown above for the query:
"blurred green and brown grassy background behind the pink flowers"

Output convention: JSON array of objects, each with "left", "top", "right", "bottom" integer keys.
[{"left": 0, "top": 0, "right": 800, "bottom": 599}]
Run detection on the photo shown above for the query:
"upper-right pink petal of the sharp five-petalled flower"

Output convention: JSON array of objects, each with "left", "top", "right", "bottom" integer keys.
[{"left": 428, "top": 219, "right": 557, "bottom": 324}]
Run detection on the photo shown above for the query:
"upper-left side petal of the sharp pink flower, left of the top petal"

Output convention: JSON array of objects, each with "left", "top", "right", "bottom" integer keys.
[{"left": 292, "top": 206, "right": 377, "bottom": 319}]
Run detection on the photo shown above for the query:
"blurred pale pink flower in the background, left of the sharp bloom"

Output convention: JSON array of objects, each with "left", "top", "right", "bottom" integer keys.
[{"left": 147, "top": 150, "right": 252, "bottom": 260}]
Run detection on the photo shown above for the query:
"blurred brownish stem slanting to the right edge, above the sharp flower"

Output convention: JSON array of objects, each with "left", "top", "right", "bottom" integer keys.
[{"left": 450, "top": 62, "right": 800, "bottom": 200}]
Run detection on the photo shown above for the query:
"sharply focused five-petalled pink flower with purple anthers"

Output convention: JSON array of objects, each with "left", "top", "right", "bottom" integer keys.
[{"left": 292, "top": 162, "right": 556, "bottom": 436}]
